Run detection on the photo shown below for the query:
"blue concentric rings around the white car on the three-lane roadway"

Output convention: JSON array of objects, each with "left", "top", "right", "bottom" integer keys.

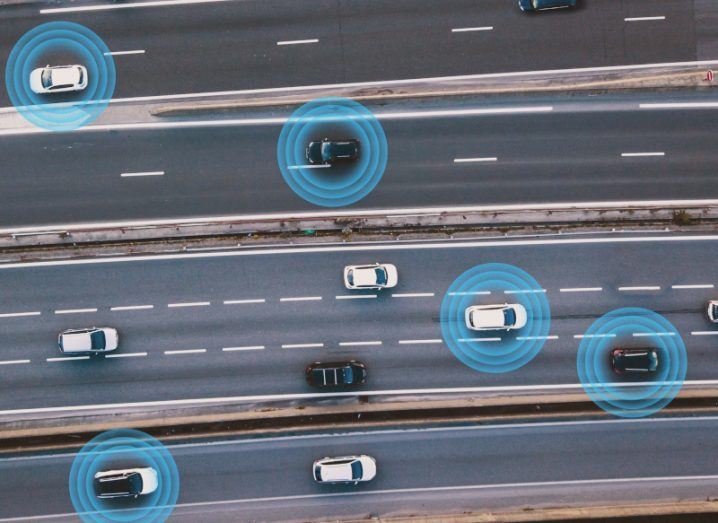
[{"left": 440, "top": 263, "right": 551, "bottom": 373}]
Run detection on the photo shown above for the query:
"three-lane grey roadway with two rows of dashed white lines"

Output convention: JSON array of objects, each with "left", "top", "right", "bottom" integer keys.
[{"left": 0, "top": 234, "right": 718, "bottom": 417}]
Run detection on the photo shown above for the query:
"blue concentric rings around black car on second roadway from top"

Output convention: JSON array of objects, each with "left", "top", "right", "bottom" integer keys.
[{"left": 277, "top": 98, "right": 389, "bottom": 207}]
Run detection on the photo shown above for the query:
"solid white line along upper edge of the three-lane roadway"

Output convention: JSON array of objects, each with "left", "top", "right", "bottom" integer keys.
[{"left": 0, "top": 234, "right": 718, "bottom": 270}]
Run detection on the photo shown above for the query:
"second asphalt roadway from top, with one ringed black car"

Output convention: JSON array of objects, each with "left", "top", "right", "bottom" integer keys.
[{"left": 0, "top": 93, "right": 718, "bottom": 227}]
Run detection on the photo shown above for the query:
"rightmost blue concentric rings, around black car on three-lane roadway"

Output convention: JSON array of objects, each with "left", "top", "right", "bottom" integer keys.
[{"left": 576, "top": 307, "right": 688, "bottom": 418}]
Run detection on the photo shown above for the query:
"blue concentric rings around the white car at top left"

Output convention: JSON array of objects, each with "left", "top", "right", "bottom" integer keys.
[{"left": 5, "top": 22, "right": 117, "bottom": 131}]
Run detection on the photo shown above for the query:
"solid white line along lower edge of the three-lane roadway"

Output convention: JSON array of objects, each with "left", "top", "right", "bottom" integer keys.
[{"left": 5, "top": 380, "right": 718, "bottom": 417}]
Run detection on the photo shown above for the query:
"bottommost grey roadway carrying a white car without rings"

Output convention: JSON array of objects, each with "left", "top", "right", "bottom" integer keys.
[{"left": 0, "top": 417, "right": 718, "bottom": 522}]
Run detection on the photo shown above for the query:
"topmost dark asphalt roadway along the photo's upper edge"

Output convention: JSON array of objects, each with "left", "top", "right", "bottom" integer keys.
[{"left": 0, "top": 0, "right": 716, "bottom": 106}]
